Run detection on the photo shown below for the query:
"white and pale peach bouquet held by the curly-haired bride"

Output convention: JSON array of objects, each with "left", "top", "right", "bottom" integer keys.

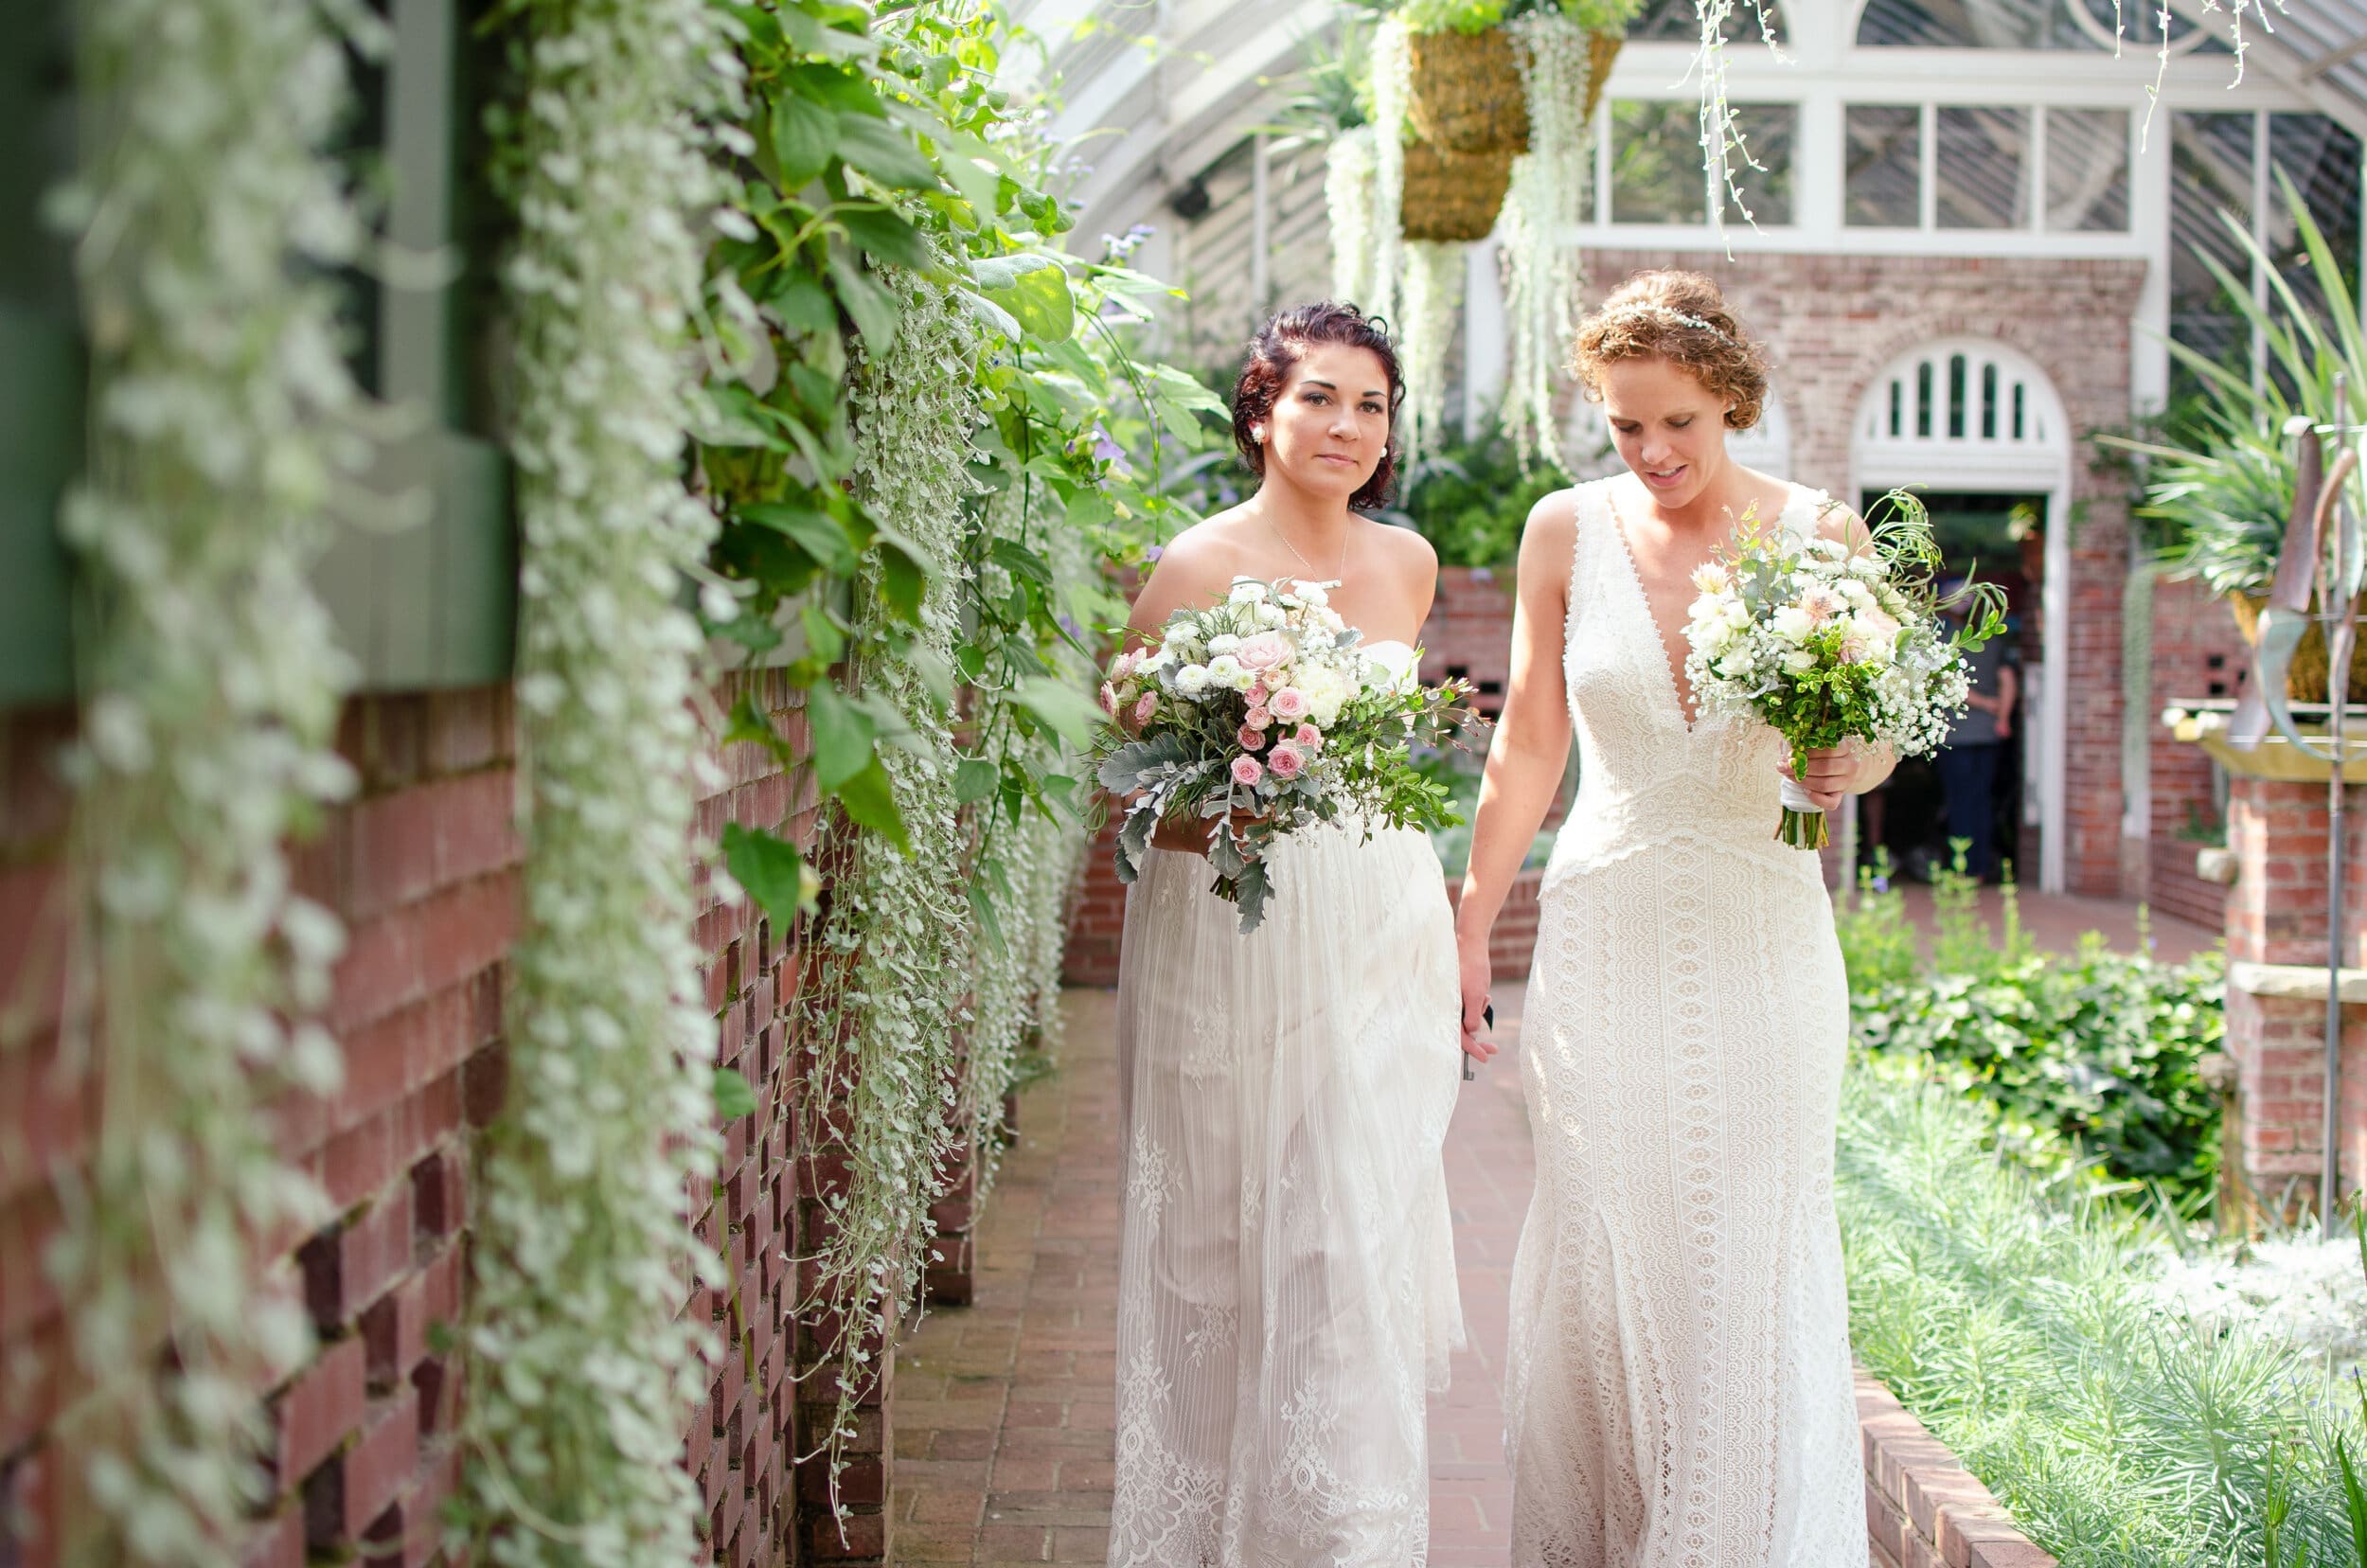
[{"left": 1685, "top": 490, "right": 2005, "bottom": 850}]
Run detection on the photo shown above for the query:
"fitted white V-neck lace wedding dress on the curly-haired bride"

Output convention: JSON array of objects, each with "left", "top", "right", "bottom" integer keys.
[{"left": 1505, "top": 483, "right": 1868, "bottom": 1568}]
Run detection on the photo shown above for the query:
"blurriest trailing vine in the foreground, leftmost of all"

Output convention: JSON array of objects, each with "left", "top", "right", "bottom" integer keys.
[{"left": 47, "top": 0, "right": 379, "bottom": 1568}]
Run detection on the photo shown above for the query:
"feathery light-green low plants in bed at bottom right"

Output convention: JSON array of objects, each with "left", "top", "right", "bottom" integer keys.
[{"left": 1835, "top": 1059, "right": 2362, "bottom": 1568}]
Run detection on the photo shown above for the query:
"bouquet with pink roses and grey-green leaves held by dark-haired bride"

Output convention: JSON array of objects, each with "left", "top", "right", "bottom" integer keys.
[{"left": 1101, "top": 578, "right": 1475, "bottom": 934}]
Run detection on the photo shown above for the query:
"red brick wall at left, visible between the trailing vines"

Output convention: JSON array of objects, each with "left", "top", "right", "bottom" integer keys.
[{"left": 0, "top": 677, "right": 888, "bottom": 1568}]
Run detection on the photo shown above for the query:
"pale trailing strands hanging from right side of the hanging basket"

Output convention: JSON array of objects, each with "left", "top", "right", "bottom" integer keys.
[{"left": 1496, "top": 14, "right": 1593, "bottom": 469}]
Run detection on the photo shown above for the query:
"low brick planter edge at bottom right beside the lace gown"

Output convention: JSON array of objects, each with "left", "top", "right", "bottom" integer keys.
[{"left": 1859, "top": 1366, "right": 2055, "bottom": 1568}]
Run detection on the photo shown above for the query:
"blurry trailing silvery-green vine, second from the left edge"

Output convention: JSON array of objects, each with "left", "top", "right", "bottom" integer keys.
[{"left": 467, "top": 0, "right": 739, "bottom": 1568}]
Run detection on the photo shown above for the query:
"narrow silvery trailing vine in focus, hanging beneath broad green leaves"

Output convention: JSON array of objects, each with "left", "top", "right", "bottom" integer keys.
[{"left": 798, "top": 270, "right": 980, "bottom": 1488}]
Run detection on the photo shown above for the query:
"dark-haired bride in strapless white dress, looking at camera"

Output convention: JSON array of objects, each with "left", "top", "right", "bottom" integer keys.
[{"left": 1111, "top": 303, "right": 1491, "bottom": 1568}]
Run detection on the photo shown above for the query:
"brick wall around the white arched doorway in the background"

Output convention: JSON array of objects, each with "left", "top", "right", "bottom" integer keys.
[{"left": 1584, "top": 251, "right": 2145, "bottom": 896}]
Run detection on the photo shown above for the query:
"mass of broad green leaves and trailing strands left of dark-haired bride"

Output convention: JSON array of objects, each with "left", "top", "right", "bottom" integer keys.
[{"left": 699, "top": 3, "right": 1219, "bottom": 1515}]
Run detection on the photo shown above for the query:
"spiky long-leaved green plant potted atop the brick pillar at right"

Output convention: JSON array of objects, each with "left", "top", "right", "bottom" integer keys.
[{"left": 2097, "top": 170, "right": 2367, "bottom": 595}]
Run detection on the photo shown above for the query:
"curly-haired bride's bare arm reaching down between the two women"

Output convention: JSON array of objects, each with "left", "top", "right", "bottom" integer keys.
[{"left": 1456, "top": 490, "right": 1576, "bottom": 1061}]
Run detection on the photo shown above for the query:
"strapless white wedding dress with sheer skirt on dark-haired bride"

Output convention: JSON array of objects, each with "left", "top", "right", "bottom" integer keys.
[{"left": 1111, "top": 644, "right": 1463, "bottom": 1568}]
